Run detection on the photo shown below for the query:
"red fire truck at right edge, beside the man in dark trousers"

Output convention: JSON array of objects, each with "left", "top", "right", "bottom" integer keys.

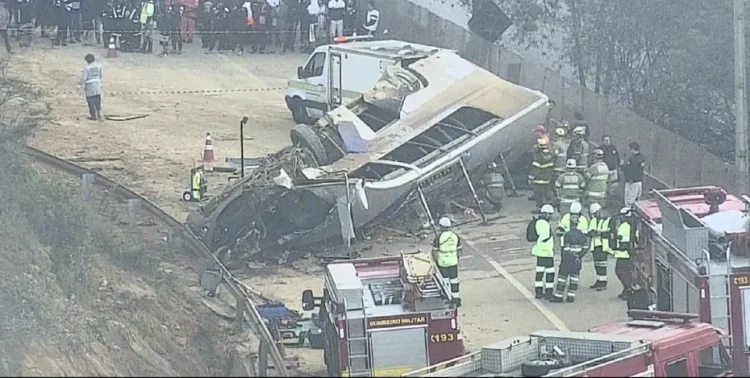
[{"left": 635, "top": 186, "right": 750, "bottom": 375}]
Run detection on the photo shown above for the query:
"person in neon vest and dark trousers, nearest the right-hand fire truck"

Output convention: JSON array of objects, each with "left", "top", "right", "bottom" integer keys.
[{"left": 610, "top": 207, "right": 638, "bottom": 300}]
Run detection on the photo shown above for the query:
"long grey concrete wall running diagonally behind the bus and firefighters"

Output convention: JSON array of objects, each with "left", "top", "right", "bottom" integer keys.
[{"left": 378, "top": 0, "right": 736, "bottom": 191}]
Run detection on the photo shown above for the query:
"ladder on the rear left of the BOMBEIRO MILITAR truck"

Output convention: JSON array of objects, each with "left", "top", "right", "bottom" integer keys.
[{"left": 344, "top": 297, "right": 370, "bottom": 377}]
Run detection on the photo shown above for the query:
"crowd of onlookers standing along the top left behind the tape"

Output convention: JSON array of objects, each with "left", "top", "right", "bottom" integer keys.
[{"left": 0, "top": 0, "right": 380, "bottom": 56}]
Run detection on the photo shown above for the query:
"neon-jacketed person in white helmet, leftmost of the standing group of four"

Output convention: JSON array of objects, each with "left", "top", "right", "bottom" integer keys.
[{"left": 531, "top": 204, "right": 555, "bottom": 299}]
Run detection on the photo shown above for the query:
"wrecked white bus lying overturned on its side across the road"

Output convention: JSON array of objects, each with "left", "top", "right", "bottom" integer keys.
[{"left": 188, "top": 51, "right": 549, "bottom": 254}]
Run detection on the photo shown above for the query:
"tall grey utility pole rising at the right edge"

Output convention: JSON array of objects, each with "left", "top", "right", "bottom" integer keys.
[{"left": 734, "top": 0, "right": 749, "bottom": 194}]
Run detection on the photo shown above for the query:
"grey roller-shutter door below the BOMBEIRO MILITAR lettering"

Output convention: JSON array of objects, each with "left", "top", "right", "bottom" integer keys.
[{"left": 370, "top": 327, "right": 427, "bottom": 377}]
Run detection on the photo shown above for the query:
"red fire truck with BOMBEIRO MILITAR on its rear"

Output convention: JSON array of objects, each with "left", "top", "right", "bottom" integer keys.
[{"left": 302, "top": 252, "right": 464, "bottom": 377}]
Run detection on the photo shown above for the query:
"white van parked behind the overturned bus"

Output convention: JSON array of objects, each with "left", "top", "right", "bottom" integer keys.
[{"left": 286, "top": 40, "right": 442, "bottom": 124}]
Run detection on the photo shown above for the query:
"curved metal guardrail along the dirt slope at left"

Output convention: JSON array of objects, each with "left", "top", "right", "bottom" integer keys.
[{"left": 24, "top": 146, "right": 289, "bottom": 377}]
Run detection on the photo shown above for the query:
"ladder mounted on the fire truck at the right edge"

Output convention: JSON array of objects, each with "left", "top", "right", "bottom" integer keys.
[{"left": 700, "top": 247, "right": 732, "bottom": 357}]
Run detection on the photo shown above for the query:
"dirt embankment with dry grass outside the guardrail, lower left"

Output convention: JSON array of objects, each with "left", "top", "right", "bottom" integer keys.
[{"left": 0, "top": 64, "right": 242, "bottom": 376}]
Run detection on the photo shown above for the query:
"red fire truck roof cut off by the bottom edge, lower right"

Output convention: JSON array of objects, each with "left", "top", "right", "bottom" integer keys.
[{"left": 402, "top": 310, "right": 734, "bottom": 377}]
